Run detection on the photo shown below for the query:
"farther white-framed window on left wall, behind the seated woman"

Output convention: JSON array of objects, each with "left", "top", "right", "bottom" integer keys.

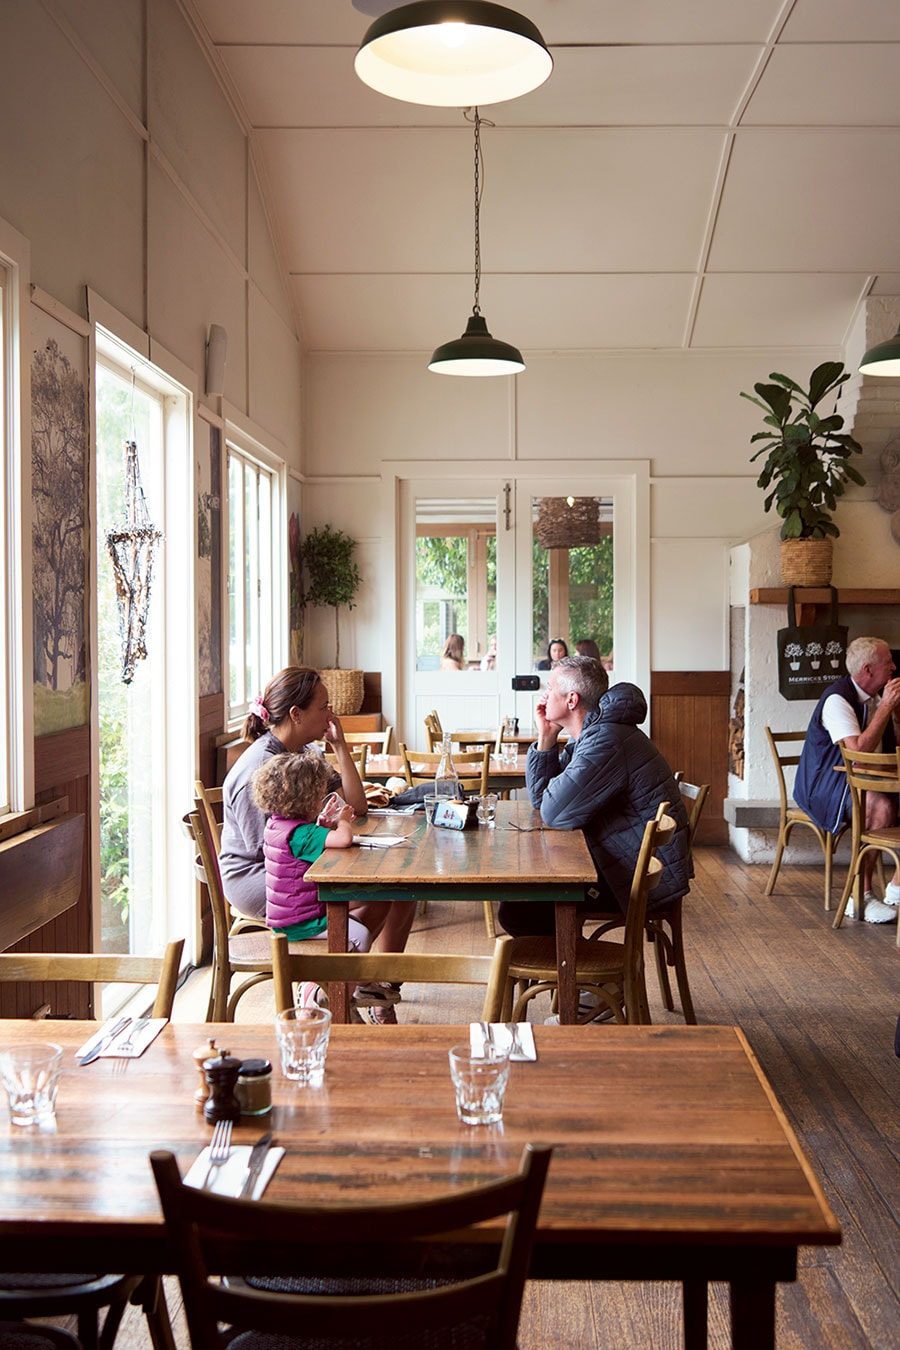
[{"left": 227, "top": 432, "right": 287, "bottom": 721}]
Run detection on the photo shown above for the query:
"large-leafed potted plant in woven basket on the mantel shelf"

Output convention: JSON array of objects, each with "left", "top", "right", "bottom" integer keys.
[{"left": 741, "top": 360, "right": 865, "bottom": 586}]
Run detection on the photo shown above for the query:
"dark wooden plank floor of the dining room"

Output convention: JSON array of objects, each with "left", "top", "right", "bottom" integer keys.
[{"left": 86, "top": 848, "right": 900, "bottom": 1350}]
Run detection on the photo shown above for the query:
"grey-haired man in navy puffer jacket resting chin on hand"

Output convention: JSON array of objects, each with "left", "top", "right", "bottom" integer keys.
[{"left": 499, "top": 656, "right": 694, "bottom": 937}]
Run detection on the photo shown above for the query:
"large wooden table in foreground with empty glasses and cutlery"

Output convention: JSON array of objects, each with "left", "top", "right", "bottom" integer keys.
[{"left": 0, "top": 1021, "right": 841, "bottom": 1350}]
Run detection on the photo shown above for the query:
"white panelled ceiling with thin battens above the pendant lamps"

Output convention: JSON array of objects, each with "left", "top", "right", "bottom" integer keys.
[{"left": 186, "top": 0, "right": 900, "bottom": 359}]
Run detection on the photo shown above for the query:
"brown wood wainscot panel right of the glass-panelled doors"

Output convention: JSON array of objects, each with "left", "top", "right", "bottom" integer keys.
[{"left": 650, "top": 671, "right": 731, "bottom": 844}]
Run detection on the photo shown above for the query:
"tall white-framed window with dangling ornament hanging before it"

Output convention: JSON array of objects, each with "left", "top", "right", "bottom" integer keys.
[{"left": 94, "top": 331, "right": 197, "bottom": 952}]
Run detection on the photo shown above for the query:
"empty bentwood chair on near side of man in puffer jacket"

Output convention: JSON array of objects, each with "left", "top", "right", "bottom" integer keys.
[{"left": 501, "top": 802, "right": 676, "bottom": 1026}]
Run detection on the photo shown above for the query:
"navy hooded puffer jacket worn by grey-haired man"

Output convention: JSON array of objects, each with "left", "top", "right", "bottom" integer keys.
[{"left": 526, "top": 683, "right": 694, "bottom": 913}]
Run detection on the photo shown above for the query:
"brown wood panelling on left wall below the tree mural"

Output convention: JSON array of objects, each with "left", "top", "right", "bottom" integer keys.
[{"left": 0, "top": 726, "right": 92, "bottom": 1018}]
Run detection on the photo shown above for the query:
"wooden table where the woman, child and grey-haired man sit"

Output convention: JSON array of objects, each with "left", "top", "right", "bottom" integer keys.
[{"left": 306, "top": 802, "right": 596, "bottom": 1022}]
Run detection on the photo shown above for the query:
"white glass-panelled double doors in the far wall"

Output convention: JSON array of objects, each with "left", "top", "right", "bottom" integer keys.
[{"left": 398, "top": 464, "right": 649, "bottom": 748}]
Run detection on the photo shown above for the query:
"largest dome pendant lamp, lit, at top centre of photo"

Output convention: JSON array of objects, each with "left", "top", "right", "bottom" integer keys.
[{"left": 354, "top": 0, "right": 553, "bottom": 108}]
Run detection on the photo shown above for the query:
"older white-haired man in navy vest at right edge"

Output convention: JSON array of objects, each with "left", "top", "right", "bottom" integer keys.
[{"left": 793, "top": 637, "right": 900, "bottom": 923}]
